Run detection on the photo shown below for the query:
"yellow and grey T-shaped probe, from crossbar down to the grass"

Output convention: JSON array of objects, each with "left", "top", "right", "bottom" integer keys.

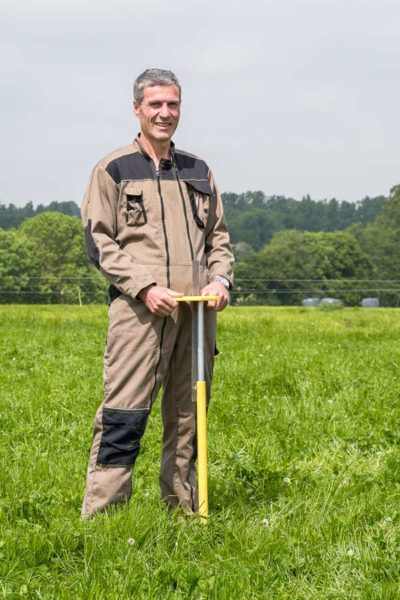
[{"left": 174, "top": 296, "right": 219, "bottom": 525}]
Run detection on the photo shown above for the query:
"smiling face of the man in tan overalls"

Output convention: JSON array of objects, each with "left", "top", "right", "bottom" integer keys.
[{"left": 133, "top": 85, "right": 181, "bottom": 143}]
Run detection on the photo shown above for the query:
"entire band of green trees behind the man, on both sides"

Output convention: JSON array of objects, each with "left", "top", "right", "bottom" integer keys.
[{"left": 0, "top": 186, "right": 400, "bottom": 305}]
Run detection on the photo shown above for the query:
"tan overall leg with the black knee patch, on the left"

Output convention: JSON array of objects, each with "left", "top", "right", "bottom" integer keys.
[{"left": 82, "top": 296, "right": 167, "bottom": 516}]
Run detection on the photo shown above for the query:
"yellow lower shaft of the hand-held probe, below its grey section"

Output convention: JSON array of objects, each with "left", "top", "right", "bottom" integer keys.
[{"left": 196, "top": 381, "right": 208, "bottom": 525}]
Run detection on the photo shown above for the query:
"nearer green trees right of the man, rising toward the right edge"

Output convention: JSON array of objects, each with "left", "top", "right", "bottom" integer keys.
[{"left": 235, "top": 186, "right": 400, "bottom": 306}]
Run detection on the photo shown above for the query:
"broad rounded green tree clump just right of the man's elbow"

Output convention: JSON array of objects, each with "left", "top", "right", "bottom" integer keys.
[{"left": 236, "top": 230, "right": 372, "bottom": 304}]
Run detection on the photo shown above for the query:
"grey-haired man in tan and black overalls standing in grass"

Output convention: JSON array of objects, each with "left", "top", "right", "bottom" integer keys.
[{"left": 82, "top": 69, "right": 233, "bottom": 517}]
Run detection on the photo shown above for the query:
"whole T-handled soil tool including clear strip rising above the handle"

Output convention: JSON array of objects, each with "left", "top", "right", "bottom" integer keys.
[{"left": 174, "top": 261, "right": 219, "bottom": 524}]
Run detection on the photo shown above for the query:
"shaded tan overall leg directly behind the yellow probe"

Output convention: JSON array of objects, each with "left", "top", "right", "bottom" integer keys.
[{"left": 160, "top": 305, "right": 216, "bottom": 513}]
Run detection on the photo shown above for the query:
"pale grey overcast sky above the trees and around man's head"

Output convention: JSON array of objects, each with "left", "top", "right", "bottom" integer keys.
[{"left": 0, "top": 0, "right": 400, "bottom": 206}]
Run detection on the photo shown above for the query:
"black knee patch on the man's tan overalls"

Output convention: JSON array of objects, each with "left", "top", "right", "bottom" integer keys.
[{"left": 97, "top": 408, "right": 149, "bottom": 467}]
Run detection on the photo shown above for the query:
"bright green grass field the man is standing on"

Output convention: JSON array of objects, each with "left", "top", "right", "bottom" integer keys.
[{"left": 0, "top": 306, "right": 400, "bottom": 600}]
